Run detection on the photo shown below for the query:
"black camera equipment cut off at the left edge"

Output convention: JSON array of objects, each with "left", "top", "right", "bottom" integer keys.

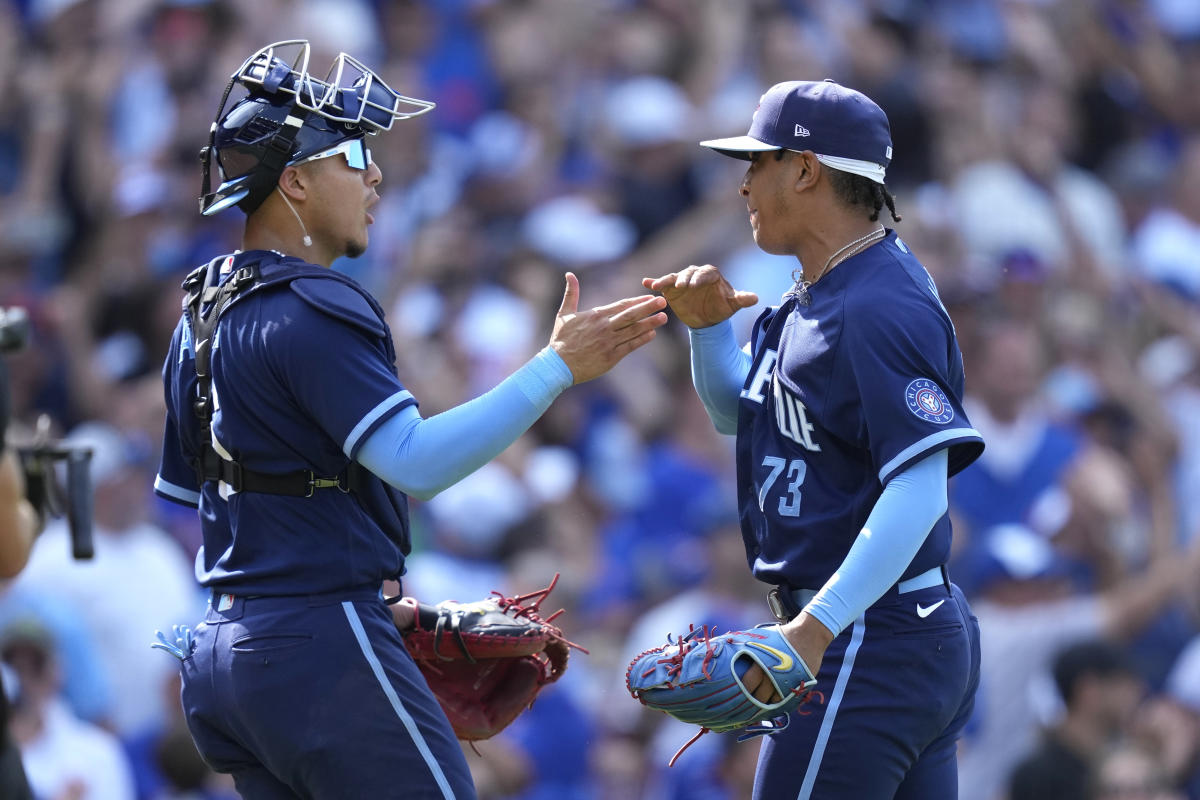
[{"left": 0, "top": 307, "right": 96, "bottom": 560}]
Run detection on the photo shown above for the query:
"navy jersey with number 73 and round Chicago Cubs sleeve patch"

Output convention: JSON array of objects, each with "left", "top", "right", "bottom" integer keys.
[{"left": 737, "top": 231, "right": 983, "bottom": 589}]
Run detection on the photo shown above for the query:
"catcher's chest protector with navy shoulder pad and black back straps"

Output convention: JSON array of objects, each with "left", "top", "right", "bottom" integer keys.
[{"left": 182, "top": 254, "right": 396, "bottom": 498}]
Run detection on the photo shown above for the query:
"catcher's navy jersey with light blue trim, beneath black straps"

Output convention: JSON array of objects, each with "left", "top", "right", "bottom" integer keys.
[{"left": 155, "top": 251, "right": 415, "bottom": 595}]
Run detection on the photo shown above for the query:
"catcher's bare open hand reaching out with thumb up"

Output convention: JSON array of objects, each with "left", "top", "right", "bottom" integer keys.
[{"left": 550, "top": 272, "right": 667, "bottom": 384}]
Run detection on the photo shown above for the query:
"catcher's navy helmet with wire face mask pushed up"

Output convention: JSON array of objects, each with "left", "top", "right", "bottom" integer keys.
[{"left": 200, "top": 40, "right": 434, "bottom": 216}]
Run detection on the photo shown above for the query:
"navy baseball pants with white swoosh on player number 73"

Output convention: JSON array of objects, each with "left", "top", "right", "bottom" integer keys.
[{"left": 754, "top": 584, "right": 979, "bottom": 800}]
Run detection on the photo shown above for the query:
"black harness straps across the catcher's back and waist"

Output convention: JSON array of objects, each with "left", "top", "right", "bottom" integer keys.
[{"left": 182, "top": 255, "right": 368, "bottom": 498}]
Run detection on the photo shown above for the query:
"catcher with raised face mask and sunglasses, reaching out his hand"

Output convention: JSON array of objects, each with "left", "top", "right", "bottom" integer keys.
[{"left": 155, "top": 40, "right": 666, "bottom": 800}]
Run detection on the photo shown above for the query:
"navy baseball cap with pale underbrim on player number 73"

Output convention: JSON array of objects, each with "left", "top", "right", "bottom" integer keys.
[{"left": 700, "top": 78, "right": 892, "bottom": 184}]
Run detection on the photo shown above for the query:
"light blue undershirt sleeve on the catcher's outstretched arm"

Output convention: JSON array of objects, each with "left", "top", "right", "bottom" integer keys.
[{"left": 358, "top": 347, "right": 574, "bottom": 500}]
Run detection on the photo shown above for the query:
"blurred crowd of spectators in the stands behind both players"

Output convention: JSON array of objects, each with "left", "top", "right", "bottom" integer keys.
[{"left": 0, "top": 0, "right": 1200, "bottom": 800}]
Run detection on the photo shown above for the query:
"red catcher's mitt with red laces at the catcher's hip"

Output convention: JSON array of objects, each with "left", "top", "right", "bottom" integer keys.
[{"left": 402, "top": 575, "right": 587, "bottom": 741}]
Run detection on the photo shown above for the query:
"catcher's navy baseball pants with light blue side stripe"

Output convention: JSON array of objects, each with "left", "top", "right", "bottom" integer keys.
[{"left": 182, "top": 590, "right": 475, "bottom": 800}]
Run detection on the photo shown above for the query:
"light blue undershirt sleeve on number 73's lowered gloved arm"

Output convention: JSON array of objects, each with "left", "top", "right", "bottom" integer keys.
[{"left": 804, "top": 450, "right": 948, "bottom": 636}]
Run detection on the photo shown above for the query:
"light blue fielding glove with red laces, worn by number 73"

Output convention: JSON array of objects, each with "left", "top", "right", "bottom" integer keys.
[{"left": 625, "top": 625, "right": 820, "bottom": 765}]
